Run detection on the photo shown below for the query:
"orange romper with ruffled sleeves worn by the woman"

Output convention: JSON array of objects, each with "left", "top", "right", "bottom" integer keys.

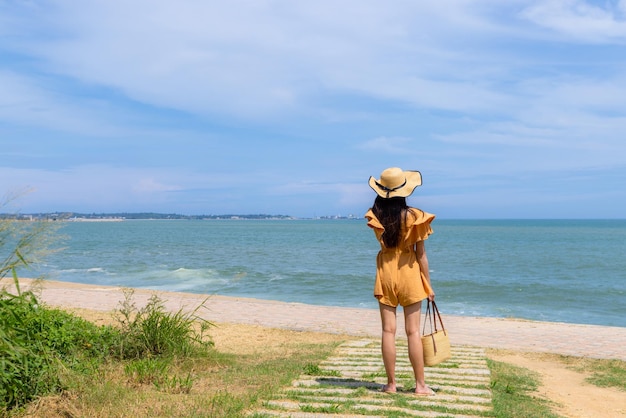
[{"left": 365, "top": 208, "right": 435, "bottom": 307}]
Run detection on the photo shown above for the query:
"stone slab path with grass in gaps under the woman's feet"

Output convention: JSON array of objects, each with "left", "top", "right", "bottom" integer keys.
[{"left": 250, "top": 339, "right": 491, "bottom": 418}]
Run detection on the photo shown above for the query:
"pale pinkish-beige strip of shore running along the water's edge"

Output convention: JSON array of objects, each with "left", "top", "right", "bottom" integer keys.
[{"left": 2, "top": 279, "right": 626, "bottom": 361}]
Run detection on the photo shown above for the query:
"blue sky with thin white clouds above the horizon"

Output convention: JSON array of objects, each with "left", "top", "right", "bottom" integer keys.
[{"left": 0, "top": 0, "right": 626, "bottom": 218}]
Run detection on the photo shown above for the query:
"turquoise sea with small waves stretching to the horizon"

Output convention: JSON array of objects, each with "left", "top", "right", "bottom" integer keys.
[{"left": 20, "top": 219, "right": 626, "bottom": 327}]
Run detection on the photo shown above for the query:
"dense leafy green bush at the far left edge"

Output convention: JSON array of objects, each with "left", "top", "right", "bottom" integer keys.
[{"left": 0, "top": 290, "right": 113, "bottom": 409}]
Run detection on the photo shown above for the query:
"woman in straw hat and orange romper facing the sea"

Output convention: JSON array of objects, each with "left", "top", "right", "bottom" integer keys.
[{"left": 365, "top": 167, "right": 435, "bottom": 396}]
